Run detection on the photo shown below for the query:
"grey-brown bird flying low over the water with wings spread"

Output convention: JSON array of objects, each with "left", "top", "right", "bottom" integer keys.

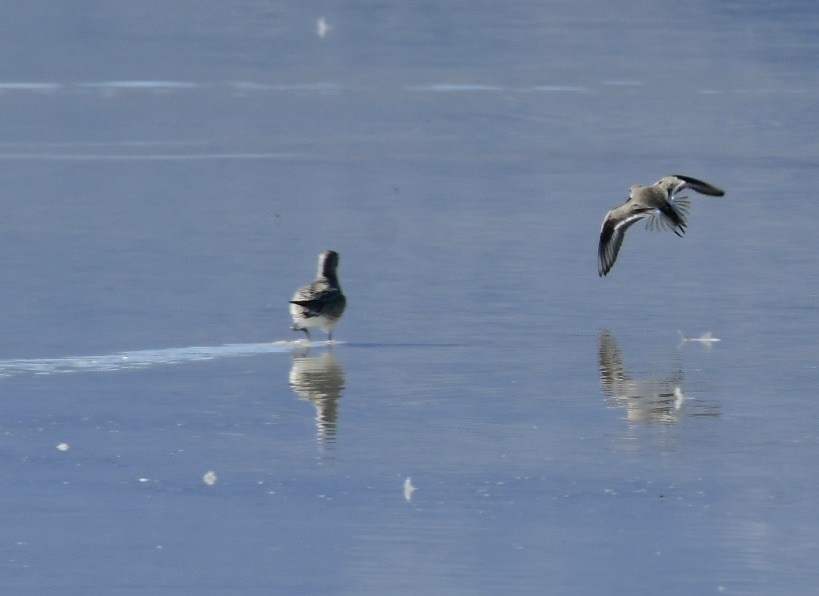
[{"left": 597, "top": 174, "right": 725, "bottom": 277}]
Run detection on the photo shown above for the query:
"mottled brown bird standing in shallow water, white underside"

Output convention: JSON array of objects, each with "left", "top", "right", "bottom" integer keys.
[{"left": 290, "top": 250, "right": 347, "bottom": 341}]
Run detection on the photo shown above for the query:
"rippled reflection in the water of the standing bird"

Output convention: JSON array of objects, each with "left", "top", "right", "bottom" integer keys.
[{"left": 289, "top": 351, "right": 344, "bottom": 443}]
